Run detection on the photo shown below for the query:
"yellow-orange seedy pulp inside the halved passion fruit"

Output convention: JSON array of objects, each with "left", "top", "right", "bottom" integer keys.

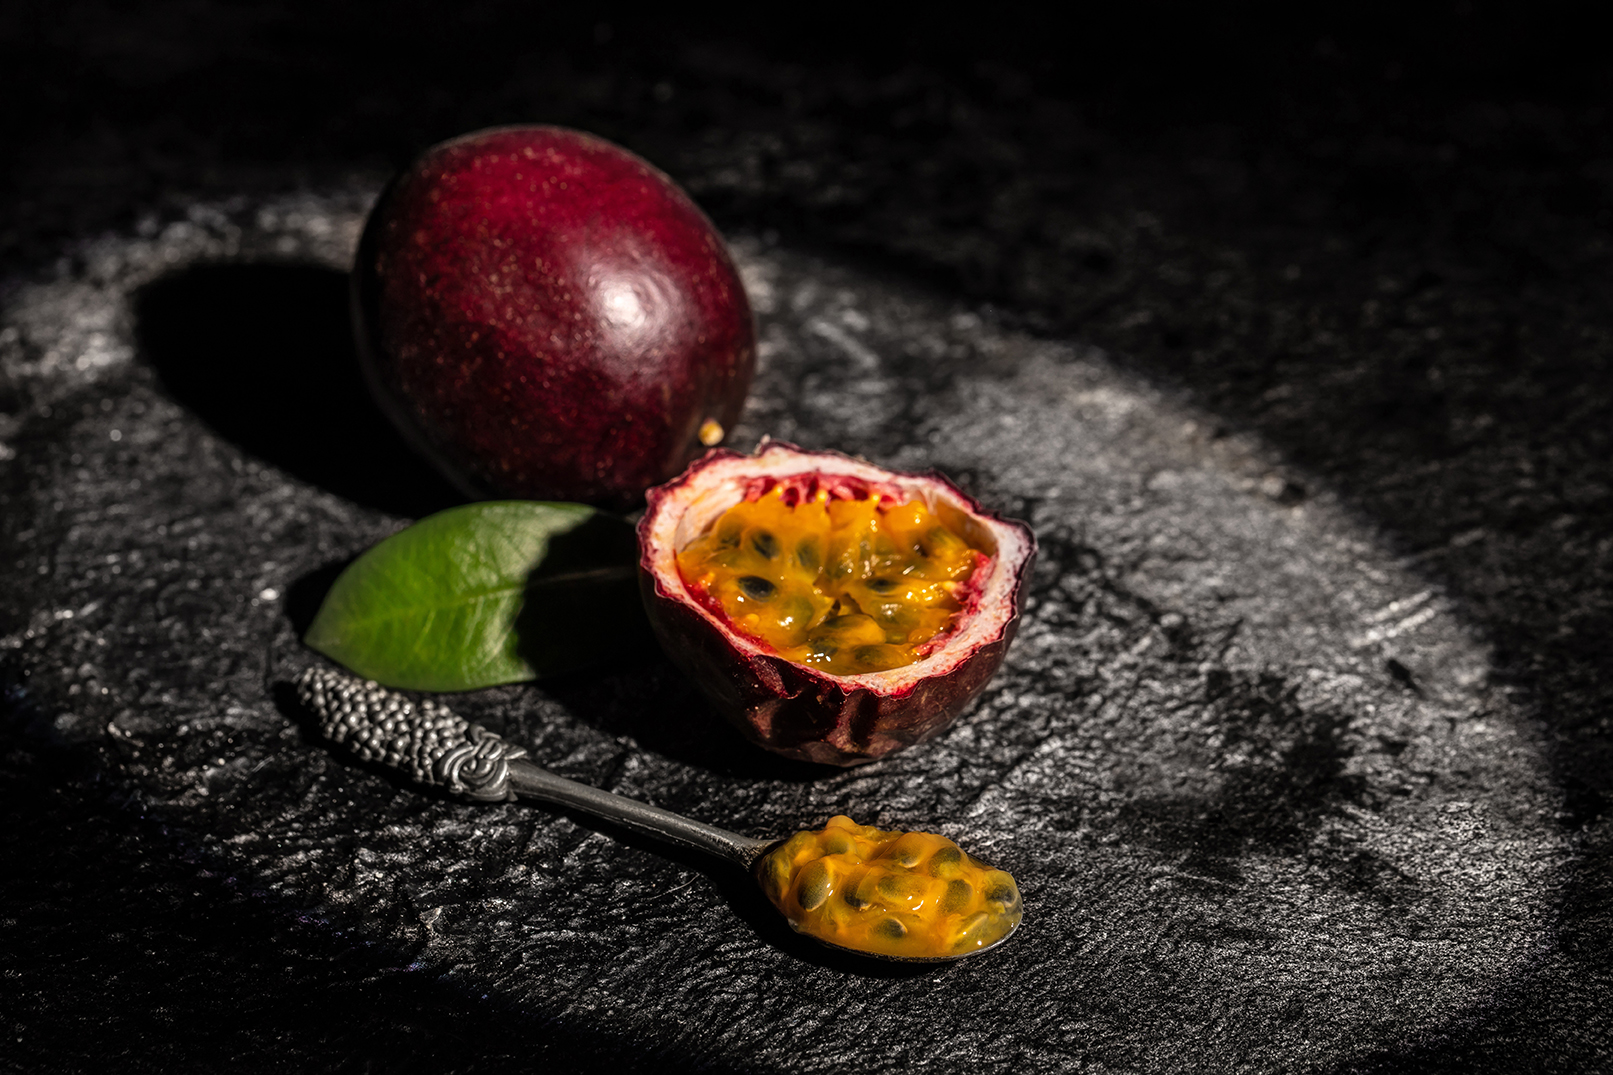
[{"left": 677, "top": 487, "right": 984, "bottom": 676}]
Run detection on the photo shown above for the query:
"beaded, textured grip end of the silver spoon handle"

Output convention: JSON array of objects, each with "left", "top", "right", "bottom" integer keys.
[{"left": 295, "top": 668, "right": 526, "bottom": 802}]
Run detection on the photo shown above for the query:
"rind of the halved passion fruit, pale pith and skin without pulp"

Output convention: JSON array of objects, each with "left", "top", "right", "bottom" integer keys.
[{"left": 639, "top": 441, "right": 1036, "bottom": 765}]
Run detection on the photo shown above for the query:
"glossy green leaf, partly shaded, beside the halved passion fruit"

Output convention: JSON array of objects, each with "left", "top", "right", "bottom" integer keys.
[{"left": 303, "top": 500, "right": 647, "bottom": 691}]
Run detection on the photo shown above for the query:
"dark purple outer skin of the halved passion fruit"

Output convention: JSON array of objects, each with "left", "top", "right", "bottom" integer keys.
[{"left": 639, "top": 442, "right": 1034, "bottom": 765}]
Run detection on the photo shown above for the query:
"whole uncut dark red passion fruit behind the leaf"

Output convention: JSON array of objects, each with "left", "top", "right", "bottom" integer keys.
[{"left": 353, "top": 126, "right": 756, "bottom": 508}]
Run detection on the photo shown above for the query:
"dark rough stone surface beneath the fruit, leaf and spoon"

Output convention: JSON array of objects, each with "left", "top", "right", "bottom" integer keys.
[{"left": 0, "top": 5, "right": 1613, "bottom": 1072}]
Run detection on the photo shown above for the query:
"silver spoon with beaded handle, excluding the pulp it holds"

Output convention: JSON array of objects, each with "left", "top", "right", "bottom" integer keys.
[{"left": 295, "top": 668, "right": 1018, "bottom": 964}]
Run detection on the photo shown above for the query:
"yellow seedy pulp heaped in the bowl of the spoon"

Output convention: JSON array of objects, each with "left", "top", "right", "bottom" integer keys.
[{"left": 760, "top": 815, "right": 1021, "bottom": 959}]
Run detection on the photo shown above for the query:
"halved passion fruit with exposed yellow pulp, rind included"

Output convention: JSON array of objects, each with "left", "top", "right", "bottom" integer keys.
[{"left": 639, "top": 442, "right": 1036, "bottom": 765}]
